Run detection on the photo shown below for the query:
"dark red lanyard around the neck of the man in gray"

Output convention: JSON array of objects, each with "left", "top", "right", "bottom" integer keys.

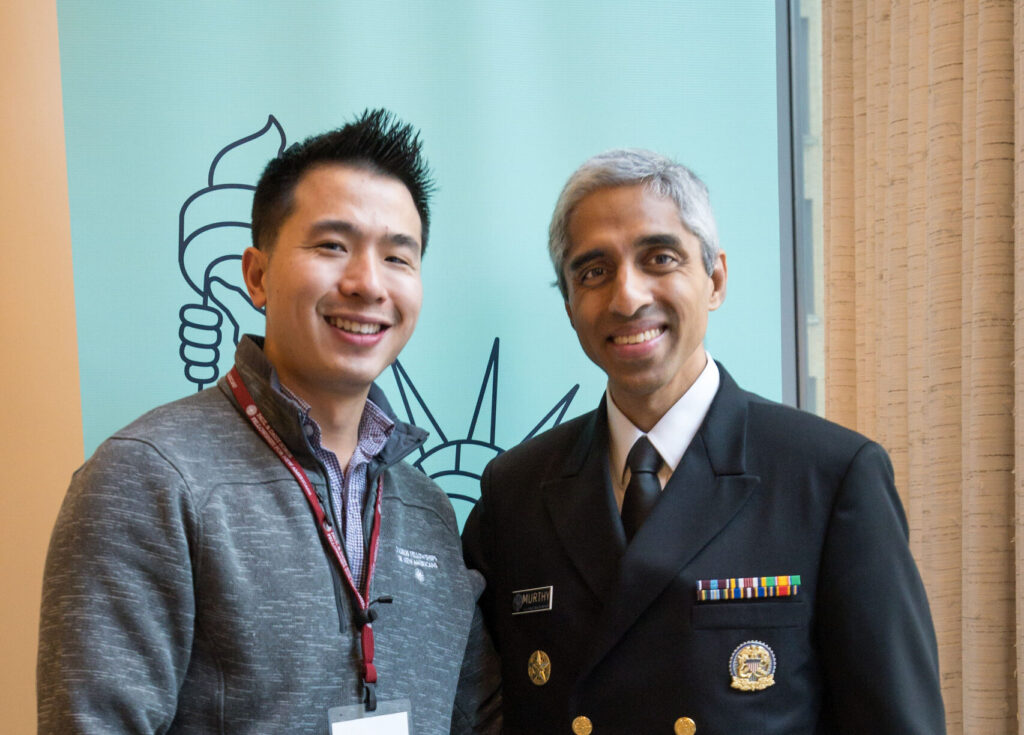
[{"left": 227, "top": 368, "right": 390, "bottom": 709}]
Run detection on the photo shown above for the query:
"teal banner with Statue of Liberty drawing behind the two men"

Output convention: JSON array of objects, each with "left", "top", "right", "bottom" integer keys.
[{"left": 57, "top": 0, "right": 782, "bottom": 521}]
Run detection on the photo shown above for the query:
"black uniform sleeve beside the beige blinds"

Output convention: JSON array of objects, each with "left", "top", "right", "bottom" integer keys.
[{"left": 816, "top": 442, "right": 946, "bottom": 735}]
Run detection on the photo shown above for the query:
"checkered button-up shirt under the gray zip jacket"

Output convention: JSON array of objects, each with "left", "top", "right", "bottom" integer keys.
[{"left": 271, "top": 375, "right": 394, "bottom": 593}]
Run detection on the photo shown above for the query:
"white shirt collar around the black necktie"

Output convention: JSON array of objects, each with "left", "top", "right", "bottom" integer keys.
[{"left": 605, "top": 353, "right": 721, "bottom": 486}]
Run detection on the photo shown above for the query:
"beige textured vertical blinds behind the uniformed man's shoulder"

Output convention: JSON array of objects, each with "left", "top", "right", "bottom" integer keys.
[{"left": 822, "top": 0, "right": 1024, "bottom": 735}]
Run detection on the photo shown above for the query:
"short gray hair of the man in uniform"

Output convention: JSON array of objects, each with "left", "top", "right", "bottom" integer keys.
[{"left": 548, "top": 148, "right": 719, "bottom": 299}]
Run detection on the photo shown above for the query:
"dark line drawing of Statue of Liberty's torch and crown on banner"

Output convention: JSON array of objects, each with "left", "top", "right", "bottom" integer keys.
[{"left": 172, "top": 115, "right": 580, "bottom": 511}]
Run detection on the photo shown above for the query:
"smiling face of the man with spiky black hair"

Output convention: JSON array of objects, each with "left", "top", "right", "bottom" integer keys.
[{"left": 243, "top": 164, "right": 423, "bottom": 405}]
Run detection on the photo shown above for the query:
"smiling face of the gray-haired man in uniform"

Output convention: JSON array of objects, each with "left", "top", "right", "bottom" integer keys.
[{"left": 565, "top": 184, "right": 726, "bottom": 431}]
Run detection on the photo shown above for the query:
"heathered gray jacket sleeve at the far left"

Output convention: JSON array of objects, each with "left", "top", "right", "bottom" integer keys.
[{"left": 37, "top": 439, "right": 196, "bottom": 735}]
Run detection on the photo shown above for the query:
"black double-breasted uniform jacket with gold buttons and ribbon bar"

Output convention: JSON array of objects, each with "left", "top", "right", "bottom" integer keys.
[{"left": 463, "top": 370, "right": 945, "bottom": 735}]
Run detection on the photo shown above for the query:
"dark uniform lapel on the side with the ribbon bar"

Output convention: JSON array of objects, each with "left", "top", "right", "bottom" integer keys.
[{"left": 587, "top": 366, "right": 759, "bottom": 683}]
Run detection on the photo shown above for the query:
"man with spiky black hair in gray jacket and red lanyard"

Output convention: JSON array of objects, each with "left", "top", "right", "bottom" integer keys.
[{"left": 38, "top": 110, "right": 501, "bottom": 735}]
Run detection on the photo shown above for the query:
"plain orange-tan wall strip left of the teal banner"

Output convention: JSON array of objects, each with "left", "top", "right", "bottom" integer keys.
[{"left": 0, "top": 0, "right": 83, "bottom": 735}]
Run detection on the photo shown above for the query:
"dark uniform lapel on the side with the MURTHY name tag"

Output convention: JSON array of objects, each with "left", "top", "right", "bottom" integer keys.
[{"left": 543, "top": 399, "right": 626, "bottom": 602}]
